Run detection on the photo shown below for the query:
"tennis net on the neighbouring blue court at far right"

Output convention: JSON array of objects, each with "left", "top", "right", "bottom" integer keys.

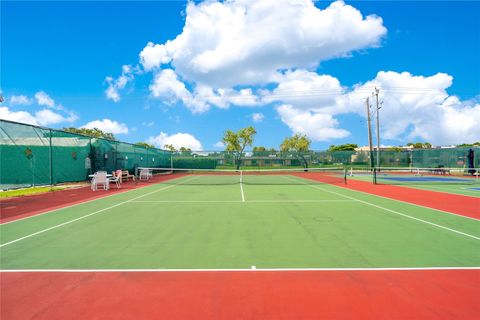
[{"left": 373, "top": 167, "right": 479, "bottom": 185}]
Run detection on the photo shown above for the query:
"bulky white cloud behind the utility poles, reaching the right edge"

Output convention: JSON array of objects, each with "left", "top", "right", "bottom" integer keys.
[{"left": 343, "top": 71, "right": 480, "bottom": 145}]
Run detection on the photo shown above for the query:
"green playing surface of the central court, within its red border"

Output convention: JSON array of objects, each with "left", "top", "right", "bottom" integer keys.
[{"left": 0, "top": 175, "right": 480, "bottom": 269}]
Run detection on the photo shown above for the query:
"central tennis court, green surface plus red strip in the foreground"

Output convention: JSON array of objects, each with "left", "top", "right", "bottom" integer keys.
[{"left": 0, "top": 169, "right": 480, "bottom": 319}]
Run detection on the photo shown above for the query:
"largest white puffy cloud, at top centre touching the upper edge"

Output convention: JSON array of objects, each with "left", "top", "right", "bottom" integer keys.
[{"left": 140, "top": 0, "right": 386, "bottom": 88}]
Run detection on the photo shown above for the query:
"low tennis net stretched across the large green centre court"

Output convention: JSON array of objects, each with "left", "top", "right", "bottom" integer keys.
[{"left": 136, "top": 167, "right": 347, "bottom": 185}]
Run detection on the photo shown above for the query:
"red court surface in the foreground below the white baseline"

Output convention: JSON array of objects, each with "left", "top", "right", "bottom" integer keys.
[{"left": 0, "top": 270, "right": 480, "bottom": 320}]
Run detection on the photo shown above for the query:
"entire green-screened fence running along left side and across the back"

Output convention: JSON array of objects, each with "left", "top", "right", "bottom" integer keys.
[{"left": 0, "top": 120, "right": 480, "bottom": 189}]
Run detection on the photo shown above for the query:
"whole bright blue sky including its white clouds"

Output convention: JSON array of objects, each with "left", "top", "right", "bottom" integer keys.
[{"left": 0, "top": 0, "right": 480, "bottom": 150}]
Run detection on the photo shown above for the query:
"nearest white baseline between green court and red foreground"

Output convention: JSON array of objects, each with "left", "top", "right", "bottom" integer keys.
[{"left": 0, "top": 267, "right": 480, "bottom": 273}]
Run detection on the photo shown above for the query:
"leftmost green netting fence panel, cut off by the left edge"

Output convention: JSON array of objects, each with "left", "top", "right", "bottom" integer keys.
[{"left": 0, "top": 121, "right": 50, "bottom": 189}]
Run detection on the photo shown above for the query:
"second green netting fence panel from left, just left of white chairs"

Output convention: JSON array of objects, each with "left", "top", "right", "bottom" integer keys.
[{"left": 51, "top": 130, "right": 91, "bottom": 184}]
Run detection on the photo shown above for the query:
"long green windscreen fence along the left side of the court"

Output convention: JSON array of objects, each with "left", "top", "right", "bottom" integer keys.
[{"left": 0, "top": 120, "right": 176, "bottom": 190}]
